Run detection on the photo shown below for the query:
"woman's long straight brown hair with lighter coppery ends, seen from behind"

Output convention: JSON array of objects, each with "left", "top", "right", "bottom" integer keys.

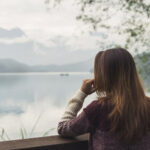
[{"left": 94, "top": 48, "right": 150, "bottom": 144}]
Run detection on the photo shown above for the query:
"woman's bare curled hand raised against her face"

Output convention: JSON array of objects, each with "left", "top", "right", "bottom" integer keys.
[{"left": 80, "top": 79, "right": 96, "bottom": 95}]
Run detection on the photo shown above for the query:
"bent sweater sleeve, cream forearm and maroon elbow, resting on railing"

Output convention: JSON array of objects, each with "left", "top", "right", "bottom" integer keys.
[{"left": 57, "top": 90, "right": 90, "bottom": 137}]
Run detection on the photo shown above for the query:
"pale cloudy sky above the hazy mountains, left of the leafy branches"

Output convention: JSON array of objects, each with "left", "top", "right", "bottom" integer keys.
[{"left": 0, "top": 0, "right": 102, "bottom": 65}]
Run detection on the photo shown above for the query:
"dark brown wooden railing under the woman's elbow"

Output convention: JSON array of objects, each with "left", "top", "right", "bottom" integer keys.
[{"left": 0, "top": 134, "right": 89, "bottom": 150}]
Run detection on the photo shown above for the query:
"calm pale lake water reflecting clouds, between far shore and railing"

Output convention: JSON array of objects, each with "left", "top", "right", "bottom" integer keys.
[{"left": 0, "top": 73, "right": 96, "bottom": 140}]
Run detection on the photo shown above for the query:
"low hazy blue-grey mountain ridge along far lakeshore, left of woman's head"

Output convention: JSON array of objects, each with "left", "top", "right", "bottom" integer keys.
[{"left": 0, "top": 59, "right": 93, "bottom": 73}]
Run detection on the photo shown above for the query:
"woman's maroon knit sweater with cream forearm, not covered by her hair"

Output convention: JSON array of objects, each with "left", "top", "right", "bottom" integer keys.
[{"left": 57, "top": 90, "right": 150, "bottom": 150}]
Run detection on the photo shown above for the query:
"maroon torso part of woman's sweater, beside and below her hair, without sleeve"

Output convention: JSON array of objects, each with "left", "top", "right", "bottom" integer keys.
[{"left": 83, "top": 100, "right": 150, "bottom": 150}]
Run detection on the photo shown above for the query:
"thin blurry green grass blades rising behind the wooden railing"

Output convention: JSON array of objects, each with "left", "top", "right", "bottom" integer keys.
[{"left": 0, "top": 114, "right": 56, "bottom": 141}]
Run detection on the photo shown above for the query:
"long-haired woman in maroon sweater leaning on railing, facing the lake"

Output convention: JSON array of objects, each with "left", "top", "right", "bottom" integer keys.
[{"left": 58, "top": 48, "right": 150, "bottom": 150}]
